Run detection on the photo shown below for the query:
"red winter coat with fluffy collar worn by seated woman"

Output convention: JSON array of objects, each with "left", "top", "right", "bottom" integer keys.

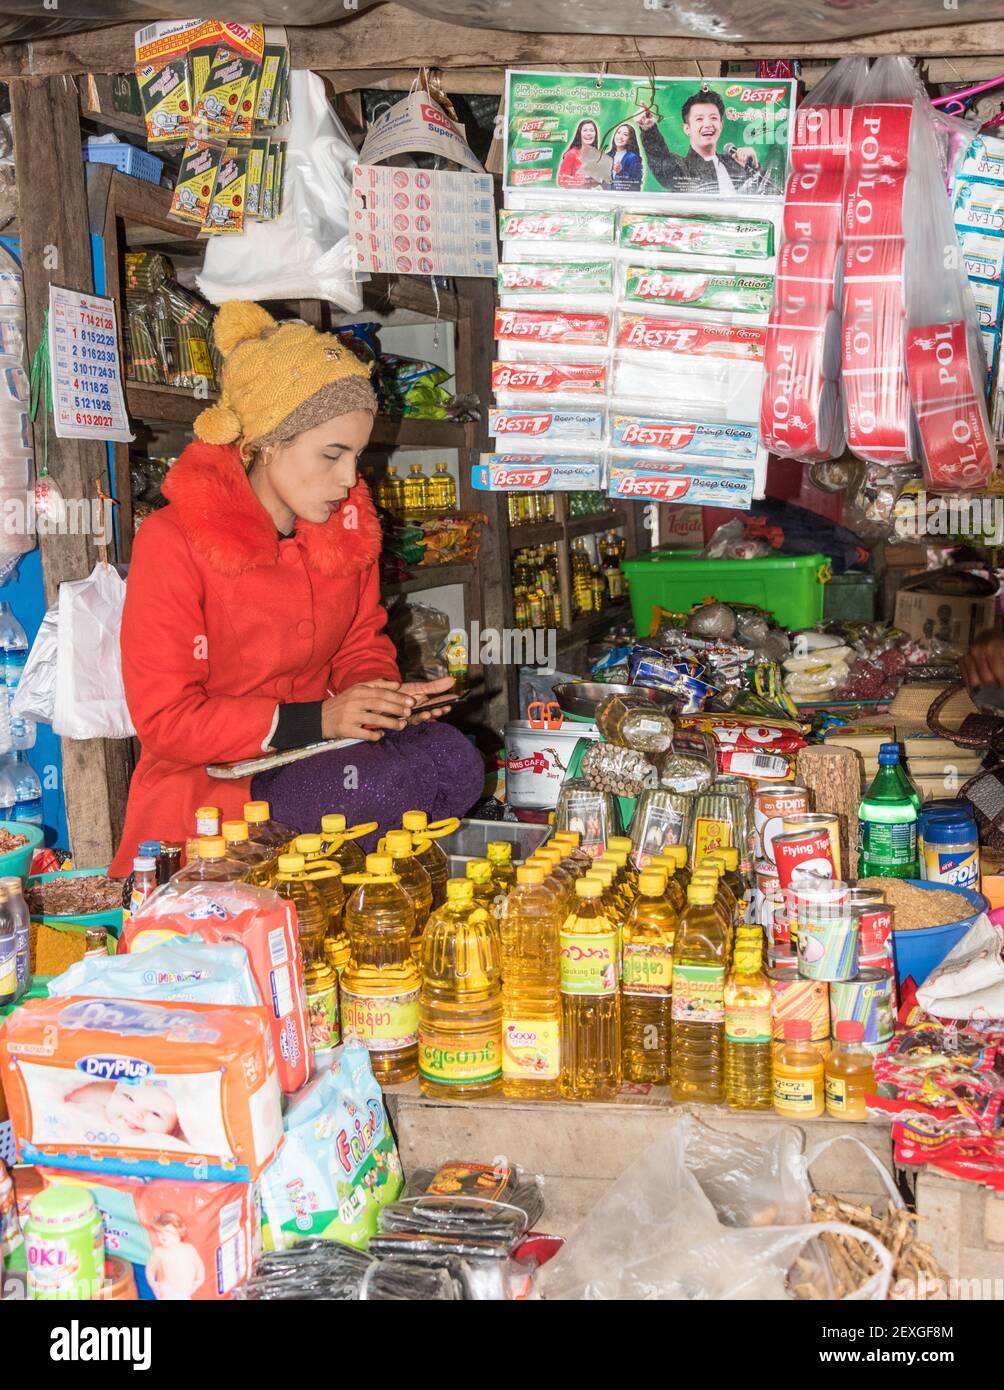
[{"left": 111, "top": 443, "right": 400, "bottom": 877}]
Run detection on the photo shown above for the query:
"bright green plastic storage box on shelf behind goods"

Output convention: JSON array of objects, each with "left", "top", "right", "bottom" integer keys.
[{"left": 620, "top": 550, "right": 830, "bottom": 637}]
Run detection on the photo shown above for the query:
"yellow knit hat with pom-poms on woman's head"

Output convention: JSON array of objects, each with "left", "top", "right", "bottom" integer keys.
[{"left": 195, "top": 299, "right": 377, "bottom": 445}]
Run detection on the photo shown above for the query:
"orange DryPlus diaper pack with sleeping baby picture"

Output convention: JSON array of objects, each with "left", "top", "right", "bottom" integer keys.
[{"left": 0, "top": 998, "right": 282, "bottom": 1183}]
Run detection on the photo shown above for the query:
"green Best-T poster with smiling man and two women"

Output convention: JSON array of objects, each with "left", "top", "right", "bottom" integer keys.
[{"left": 505, "top": 71, "right": 794, "bottom": 199}]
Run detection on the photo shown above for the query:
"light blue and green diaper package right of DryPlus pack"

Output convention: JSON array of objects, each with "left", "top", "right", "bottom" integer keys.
[{"left": 261, "top": 1041, "right": 402, "bottom": 1250}]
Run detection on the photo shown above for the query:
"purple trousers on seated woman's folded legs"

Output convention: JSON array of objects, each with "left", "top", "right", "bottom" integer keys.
[{"left": 252, "top": 721, "right": 484, "bottom": 853}]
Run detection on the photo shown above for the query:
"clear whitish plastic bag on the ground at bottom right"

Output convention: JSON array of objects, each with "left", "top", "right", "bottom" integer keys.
[{"left": 537, "top": 1115, "right": 894, "bottom": 1301}]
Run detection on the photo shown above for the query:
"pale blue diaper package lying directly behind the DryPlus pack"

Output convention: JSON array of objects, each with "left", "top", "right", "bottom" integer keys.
[{"left": 49, "top": 937, "right": 261, "bottom": 1009}]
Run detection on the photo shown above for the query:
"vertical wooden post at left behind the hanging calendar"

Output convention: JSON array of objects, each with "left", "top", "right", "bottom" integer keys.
[{"left": 10, "top": 76, "right": 132, "bottom": 867}]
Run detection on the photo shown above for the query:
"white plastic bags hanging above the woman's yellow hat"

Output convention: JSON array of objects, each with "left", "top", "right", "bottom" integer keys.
[{"left": 197, "top": 72, "right": 363, "bottom": 313}]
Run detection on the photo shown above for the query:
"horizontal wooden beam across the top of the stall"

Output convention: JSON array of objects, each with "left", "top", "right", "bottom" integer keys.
[{"left": 9, "top": 4, "right": 1004, "bottom": 78}]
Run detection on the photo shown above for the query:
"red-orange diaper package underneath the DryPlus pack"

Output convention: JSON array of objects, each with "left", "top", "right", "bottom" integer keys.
[{"left": 22, "top": 1168, "right": 261, "bottom": 1302}]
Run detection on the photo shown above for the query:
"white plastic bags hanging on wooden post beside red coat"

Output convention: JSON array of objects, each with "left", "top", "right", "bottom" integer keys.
[{"left": 53, "top": 560, "right": 136, "bottom": 738}]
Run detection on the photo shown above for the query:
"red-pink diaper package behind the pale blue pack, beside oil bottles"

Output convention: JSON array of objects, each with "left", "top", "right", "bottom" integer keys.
[{"left": 118, "top": 883, "right": 310, "bottom": 1094}]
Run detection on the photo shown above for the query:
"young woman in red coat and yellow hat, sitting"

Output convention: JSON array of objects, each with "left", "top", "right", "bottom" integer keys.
[{"left": 111, "top": 302, "right": 484, "bottom": 876}]
